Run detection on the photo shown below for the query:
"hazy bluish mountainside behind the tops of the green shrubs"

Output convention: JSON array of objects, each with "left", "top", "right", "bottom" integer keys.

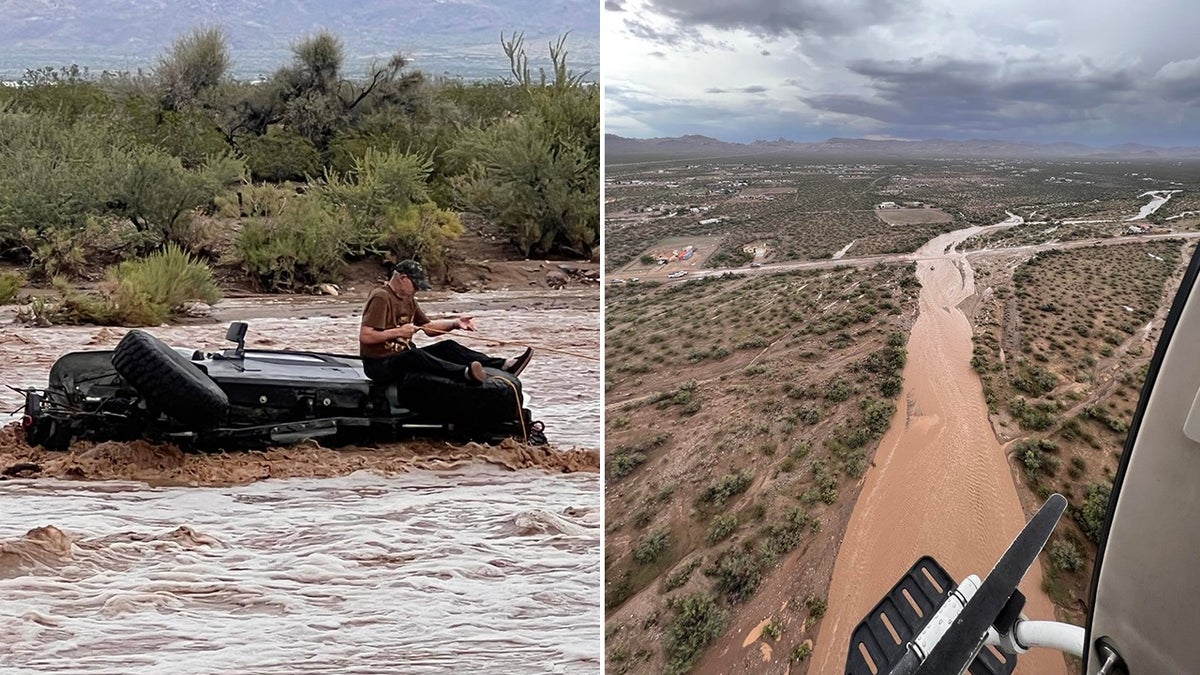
[{"left": 0, "top": 0, "right": 600, "bottom": 79}]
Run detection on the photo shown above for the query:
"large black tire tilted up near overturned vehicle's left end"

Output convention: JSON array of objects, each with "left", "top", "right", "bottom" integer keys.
[{"left": 113, "top": 330, "right": 229, "bottom": 428}]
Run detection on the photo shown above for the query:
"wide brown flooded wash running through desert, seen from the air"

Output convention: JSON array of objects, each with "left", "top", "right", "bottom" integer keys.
[{"left": 810, "top": 228, "right": 1066, "bottom": 674}]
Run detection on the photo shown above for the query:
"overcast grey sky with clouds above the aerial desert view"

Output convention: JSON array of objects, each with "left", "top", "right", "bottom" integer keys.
[{"left": 601, "top": 0, "right": 1200, "bottom": 145}]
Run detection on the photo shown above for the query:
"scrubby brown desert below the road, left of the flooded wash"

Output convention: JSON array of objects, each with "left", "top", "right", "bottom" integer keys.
[{"left": 605, "top": 265, "right": 919, "bottom": 673}]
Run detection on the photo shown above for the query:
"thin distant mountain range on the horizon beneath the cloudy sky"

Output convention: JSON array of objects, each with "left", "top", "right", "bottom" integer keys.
[{"left": 605, "top": 133, "right": 1200, "bottom": 161}]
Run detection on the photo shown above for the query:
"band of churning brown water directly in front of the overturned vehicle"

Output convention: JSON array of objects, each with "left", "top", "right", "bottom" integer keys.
[{"left": 0, "top": 424, "right": 600, "bottom": 485}]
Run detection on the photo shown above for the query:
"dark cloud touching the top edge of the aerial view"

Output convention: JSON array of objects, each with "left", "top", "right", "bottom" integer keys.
[{"left": 649, "top": 0, "right": 916, "bottom": 36}]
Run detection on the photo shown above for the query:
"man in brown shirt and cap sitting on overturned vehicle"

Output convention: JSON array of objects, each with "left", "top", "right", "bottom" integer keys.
[{"left": 359, "top": 261, "right": 533, "bottom": 383}]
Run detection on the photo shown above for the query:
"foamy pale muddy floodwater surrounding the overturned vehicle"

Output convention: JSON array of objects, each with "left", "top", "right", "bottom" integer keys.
[{"left": 0, "top": 292, "right": 602, "bottom": 674}]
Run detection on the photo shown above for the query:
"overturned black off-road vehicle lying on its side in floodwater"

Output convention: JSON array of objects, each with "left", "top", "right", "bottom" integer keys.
[{"left": 22, "top": 322, "right": 546, "bottom": 449}]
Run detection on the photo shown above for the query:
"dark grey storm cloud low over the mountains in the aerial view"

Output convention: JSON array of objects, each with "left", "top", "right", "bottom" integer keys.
[{"left": 803, "top": 59, "right": 1141, "bottom": 130}]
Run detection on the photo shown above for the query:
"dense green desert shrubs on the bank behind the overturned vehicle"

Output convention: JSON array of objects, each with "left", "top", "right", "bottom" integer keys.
[{"left": 0, "top": 28, "right": 600, "bottom": 326}]
